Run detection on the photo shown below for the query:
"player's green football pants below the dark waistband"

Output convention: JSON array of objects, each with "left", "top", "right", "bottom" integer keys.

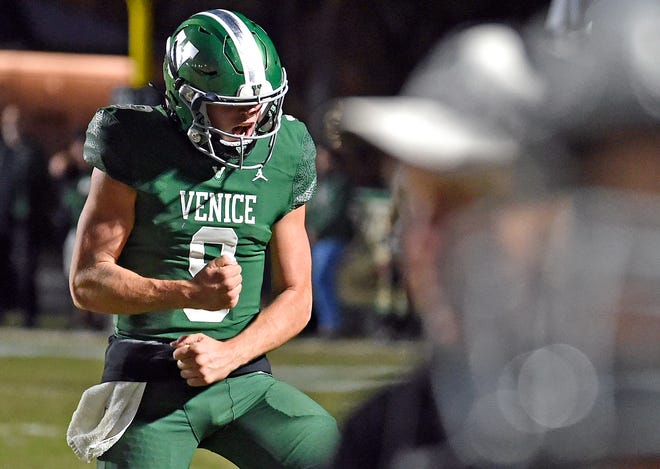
[{"left": 97, "top": 373, "right": 339, "bottom": 469}]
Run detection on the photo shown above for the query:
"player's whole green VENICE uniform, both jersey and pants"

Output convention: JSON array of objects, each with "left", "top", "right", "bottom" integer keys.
[{"left": 85, "top": 106, "right": 338, "bottom": 469}]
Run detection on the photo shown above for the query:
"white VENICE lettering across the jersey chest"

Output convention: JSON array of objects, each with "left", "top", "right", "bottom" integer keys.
[{"left": 179, "top": 190, "right": 257, "bottom": 225}]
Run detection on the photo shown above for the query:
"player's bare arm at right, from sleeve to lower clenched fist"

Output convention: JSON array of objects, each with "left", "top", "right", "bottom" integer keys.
[{"left": 173, "top": 206, "right": 312, "bottom": 386}]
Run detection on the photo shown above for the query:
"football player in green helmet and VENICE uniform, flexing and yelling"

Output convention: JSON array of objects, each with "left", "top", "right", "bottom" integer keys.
[{"left": 70, "top": 10, "right": 338, "bottom": 469}]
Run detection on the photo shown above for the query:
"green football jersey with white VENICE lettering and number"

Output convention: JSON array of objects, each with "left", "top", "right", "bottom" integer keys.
[{"left": 85, "top": 105, "right": 316, "bottom": 339}]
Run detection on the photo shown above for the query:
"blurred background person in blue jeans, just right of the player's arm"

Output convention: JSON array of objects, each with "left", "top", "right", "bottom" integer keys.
[{"left": 305, "top": 145, "right": 353, "bottom": 338}]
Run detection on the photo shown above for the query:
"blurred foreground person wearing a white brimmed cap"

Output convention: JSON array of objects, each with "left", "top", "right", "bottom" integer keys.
[{"left": 333, "top": 24, "right": 542, "bottom": 468}]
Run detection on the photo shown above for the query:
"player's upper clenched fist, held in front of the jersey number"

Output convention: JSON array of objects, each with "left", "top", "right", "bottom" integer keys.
[{"left": 191, "top": 255, "right": 243, "bottom": 311}]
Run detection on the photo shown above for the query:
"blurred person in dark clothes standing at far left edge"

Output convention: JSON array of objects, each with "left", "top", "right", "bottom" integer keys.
[{"left": 0, "top": 104, "right": 52, "bottom": 327}]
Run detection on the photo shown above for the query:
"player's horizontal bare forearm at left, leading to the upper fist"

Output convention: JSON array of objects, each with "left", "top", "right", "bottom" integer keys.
[{"left": 70, "top": 263, "right": 193, "bottom": 314}]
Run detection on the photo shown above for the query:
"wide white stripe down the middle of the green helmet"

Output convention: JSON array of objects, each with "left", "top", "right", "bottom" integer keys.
[{"left": 201, "top": 10, "right": 266, "bottom": 86}]
